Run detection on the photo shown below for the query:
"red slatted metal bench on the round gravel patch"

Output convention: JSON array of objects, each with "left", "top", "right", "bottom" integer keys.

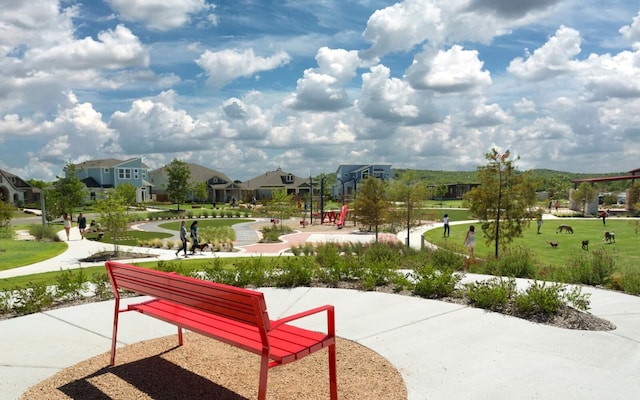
[{"left": 106, "top": 261, "right": 338, "bottom": 400}]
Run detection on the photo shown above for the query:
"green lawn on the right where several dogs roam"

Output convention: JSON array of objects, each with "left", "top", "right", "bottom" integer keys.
[{"left": 425, "top": 218, "right": 640, "bottom": 270}]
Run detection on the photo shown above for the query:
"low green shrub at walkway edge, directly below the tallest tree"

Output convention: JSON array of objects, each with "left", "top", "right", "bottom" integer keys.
[{"left": 465, "top": 278, "right": 516, "bottom": 311}]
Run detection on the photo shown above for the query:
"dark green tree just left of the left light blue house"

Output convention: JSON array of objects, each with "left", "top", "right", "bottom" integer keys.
[{"left": 50, "top": 163, "right": 87, "bottom": 218}]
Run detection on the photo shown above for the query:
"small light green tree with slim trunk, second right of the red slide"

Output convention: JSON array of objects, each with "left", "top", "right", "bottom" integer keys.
[{"left": 390, "top": 171, "right": 427, "bottom": 246}]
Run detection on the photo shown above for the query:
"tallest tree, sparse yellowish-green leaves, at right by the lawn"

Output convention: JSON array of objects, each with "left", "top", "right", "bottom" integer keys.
[{"left": 464, "top": 148, "right": 536, "bottom": 258}]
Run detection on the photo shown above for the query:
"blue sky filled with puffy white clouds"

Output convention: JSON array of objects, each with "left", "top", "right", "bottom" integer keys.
[{"left": 0, "top": 0, "right": 640, "bottom": 180}]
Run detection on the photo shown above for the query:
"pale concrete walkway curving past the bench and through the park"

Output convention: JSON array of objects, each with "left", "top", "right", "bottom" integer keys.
[{"left": 0, "top": 220, "right": 640, "bottom": 400}]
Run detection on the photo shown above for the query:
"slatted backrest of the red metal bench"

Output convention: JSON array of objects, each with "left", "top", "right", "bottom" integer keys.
[{"left": 105, "top": 261, "right": 270, "bottom": 331}]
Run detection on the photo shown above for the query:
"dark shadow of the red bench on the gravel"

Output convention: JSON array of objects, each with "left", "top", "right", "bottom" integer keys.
[{"left": 58, "top": 355, "right": 248, "bottom": 400}]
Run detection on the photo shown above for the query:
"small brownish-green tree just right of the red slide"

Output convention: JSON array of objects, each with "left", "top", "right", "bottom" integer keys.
[{"left": 353, "top": 178, "right": 391, "bottom": 242}]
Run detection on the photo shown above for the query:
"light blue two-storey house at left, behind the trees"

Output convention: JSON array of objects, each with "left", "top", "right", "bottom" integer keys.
[{"left": 74, "top": 157, "right": 153, "bottom": 203}]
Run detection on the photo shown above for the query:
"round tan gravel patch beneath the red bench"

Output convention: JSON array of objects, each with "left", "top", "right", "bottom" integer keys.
[{"left": 20, "top": 333, "right": 407, "bottom": 400}]
